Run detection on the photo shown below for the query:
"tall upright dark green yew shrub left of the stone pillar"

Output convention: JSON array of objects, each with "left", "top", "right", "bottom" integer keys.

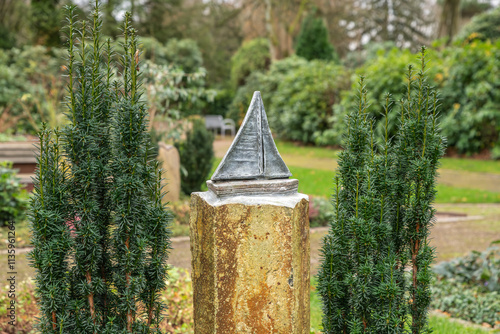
[{"left": 31, "top": 1, "right": 171, "bottom": 333}]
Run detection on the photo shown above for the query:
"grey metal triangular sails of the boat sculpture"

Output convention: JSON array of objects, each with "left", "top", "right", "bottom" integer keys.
[{"left": 212, "top": 92, "right": 292, "bottom": 181}]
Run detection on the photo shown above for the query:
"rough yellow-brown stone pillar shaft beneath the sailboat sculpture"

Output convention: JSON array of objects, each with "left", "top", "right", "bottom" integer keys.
[{"left": 190, "top": 193, "right": 309, "bottom": 334}]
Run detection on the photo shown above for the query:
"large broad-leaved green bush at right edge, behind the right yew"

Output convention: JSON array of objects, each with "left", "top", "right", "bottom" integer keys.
[{"left": 442, "top": 41, "right": 500, "bottom": 158}]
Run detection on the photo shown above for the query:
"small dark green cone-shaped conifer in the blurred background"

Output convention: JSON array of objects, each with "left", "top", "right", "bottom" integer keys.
[{"left": 295, "top": 14, "right": 339, "bottom": 62}]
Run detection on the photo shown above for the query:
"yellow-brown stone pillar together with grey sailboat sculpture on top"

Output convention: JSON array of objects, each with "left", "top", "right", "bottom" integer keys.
[{"left": 190, "top": 92, "right": 310, "bottom": 334}]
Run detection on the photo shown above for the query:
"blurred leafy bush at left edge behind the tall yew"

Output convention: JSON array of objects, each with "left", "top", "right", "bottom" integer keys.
[{"left": 0, "top": 46, "right": 64, "bottom": 134}]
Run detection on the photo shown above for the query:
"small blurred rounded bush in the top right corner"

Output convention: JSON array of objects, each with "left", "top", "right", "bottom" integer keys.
[{"left": 455, "top": 8, "right": 500, "bottom": 42}]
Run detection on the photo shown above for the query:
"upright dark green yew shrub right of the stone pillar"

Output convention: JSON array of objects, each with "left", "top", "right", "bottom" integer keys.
[{"left": 318, "top": 48, "right": 445, "bottom": 334}]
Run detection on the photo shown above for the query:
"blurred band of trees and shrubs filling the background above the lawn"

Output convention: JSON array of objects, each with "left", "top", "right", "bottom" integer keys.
[{"left": 0, "top": 0, "right": 500, "bottom": 159}]
